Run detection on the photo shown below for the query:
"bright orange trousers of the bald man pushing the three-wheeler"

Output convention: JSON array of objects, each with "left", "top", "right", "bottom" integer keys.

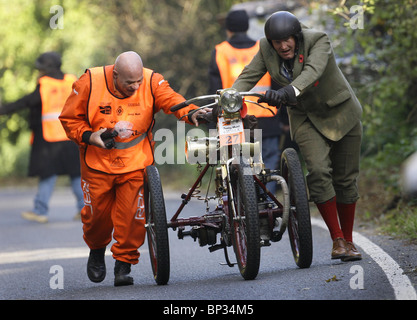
[{"left": 81, "top": 167, "right": 146, "bottom": 264}]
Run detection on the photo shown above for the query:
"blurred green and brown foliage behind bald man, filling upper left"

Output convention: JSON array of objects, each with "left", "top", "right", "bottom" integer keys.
[{"left": 0, "top": 0, "right": 242, "bottom": 176}]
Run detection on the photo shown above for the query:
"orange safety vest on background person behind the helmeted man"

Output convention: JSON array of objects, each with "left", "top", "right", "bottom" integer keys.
[{"left": 216, "top": 41, "right": 277, "bottom": 117}]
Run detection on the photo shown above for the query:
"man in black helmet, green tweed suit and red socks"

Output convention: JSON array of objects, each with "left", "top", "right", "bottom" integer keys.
[{"left": 233, "top": 11, "right": 362, "bottom": 261}]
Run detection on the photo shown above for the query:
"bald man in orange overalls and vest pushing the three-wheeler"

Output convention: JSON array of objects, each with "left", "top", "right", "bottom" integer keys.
[{"left": 59, "top": 51, "right": 206, "bottom": 286}]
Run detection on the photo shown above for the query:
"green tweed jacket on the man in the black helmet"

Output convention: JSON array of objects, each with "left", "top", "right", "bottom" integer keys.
[{"left": 233, "top": 28, "right": 362, "bottom": 141}]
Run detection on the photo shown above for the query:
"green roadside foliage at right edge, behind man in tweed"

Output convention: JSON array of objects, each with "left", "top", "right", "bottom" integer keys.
[{"left": 326, "top": 0, "right": 417, "bottom": 188}]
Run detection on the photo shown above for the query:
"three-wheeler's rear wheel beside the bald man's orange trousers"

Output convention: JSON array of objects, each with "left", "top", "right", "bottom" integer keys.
[{"left": 145, "top": 166, "right": 170, "bottom": 285}]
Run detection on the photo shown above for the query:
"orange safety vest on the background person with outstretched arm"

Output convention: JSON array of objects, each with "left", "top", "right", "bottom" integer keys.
[{"left": 39, "top": 74, "right": 77, "bottom": 142}]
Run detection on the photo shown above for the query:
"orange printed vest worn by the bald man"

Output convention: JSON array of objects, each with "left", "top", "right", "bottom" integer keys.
[{"left": 84, "top": 66, "right": 154, "bottom": 174}]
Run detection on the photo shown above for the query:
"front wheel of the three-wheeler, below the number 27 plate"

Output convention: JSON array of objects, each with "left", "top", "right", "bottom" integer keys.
[{"left": 229, "top": 160, "right": 261, "bottom": 280}]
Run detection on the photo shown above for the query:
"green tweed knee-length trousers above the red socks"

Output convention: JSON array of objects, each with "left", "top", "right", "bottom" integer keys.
[{"left": 294, "top": 120, "right": 362, "bottom": 203}]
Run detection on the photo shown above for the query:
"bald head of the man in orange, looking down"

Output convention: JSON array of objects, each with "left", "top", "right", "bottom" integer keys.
[{"left": 113, "top": 51, "right": 143, "bottom": 97}]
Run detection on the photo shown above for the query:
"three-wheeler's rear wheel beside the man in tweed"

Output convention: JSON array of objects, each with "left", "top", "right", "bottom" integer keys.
[{"left": 281, "top": 148, "right": 313, "bottom": 268}]
